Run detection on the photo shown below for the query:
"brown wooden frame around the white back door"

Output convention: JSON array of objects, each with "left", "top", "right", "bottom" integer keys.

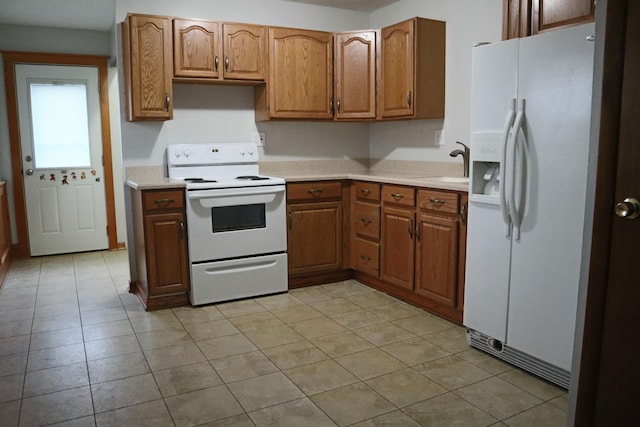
[{"left": 1, "top": 51, "right": 119, "bottom": 258}]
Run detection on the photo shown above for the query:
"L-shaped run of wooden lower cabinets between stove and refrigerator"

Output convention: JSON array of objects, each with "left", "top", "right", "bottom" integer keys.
[{"left": 287, "top": 181, "right": 467, "bottom": 323}]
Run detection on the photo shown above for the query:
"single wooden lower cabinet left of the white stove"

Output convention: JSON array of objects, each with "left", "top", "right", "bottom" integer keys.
[{"left": 129, "top": 189, "right": 190, "bottom": 310}]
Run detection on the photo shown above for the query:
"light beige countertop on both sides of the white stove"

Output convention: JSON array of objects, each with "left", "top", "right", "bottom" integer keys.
[{"left": 126, "top": 171, "right": 469, "bottom": 192}]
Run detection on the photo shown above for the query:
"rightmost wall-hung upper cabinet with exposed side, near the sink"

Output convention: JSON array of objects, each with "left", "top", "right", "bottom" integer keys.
[{"left": 378, "top": 18, "right": 446, "bottom": 119}]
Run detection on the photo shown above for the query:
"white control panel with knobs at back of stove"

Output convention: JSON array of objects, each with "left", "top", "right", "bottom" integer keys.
[{"left": 167, "top": 142, "right": 258, "bottom": 165}]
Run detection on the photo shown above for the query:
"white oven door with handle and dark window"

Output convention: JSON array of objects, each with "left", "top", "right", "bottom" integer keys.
[{"left": 187, "top": 185, "right": 287, "bottom": 263}]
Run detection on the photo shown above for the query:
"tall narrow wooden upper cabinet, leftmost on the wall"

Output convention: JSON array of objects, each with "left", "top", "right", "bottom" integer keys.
[{"left": 122, "top": 15, "right": 173, "bottom": 121}]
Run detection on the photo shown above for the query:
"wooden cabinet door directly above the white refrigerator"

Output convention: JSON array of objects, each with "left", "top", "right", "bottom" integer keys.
[{"left": 531, "top": 0, "right": 596, "bottom": 34}]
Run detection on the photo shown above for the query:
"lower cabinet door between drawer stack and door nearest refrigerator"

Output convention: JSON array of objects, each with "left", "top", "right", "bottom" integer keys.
[{"left": 380, "top": 207, "right": 415, "bottom": 290}]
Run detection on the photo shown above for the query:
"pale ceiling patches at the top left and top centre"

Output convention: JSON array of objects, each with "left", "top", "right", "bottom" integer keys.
[{"left": 0, "top": 0, "right": 399, "bottom": 31}]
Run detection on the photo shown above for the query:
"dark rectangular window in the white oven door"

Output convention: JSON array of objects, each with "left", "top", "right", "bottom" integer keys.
[{"left": 211, "top": 203, "right": 267, "bottom": 233}]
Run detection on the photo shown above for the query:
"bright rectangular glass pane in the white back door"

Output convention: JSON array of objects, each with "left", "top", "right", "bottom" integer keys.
[{"left": 29, "top": 81, "right": 91, "bottom": 169}]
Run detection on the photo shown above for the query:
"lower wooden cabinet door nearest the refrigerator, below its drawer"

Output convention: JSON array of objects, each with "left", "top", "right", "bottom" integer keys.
[{"left": 416, "top": 214, "right": 459, "bottom": 308}]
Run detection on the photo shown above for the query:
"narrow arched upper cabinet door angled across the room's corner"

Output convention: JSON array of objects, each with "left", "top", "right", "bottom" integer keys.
[{"left": 335, "top": 31, "right": 376, "bottom": 119}]
